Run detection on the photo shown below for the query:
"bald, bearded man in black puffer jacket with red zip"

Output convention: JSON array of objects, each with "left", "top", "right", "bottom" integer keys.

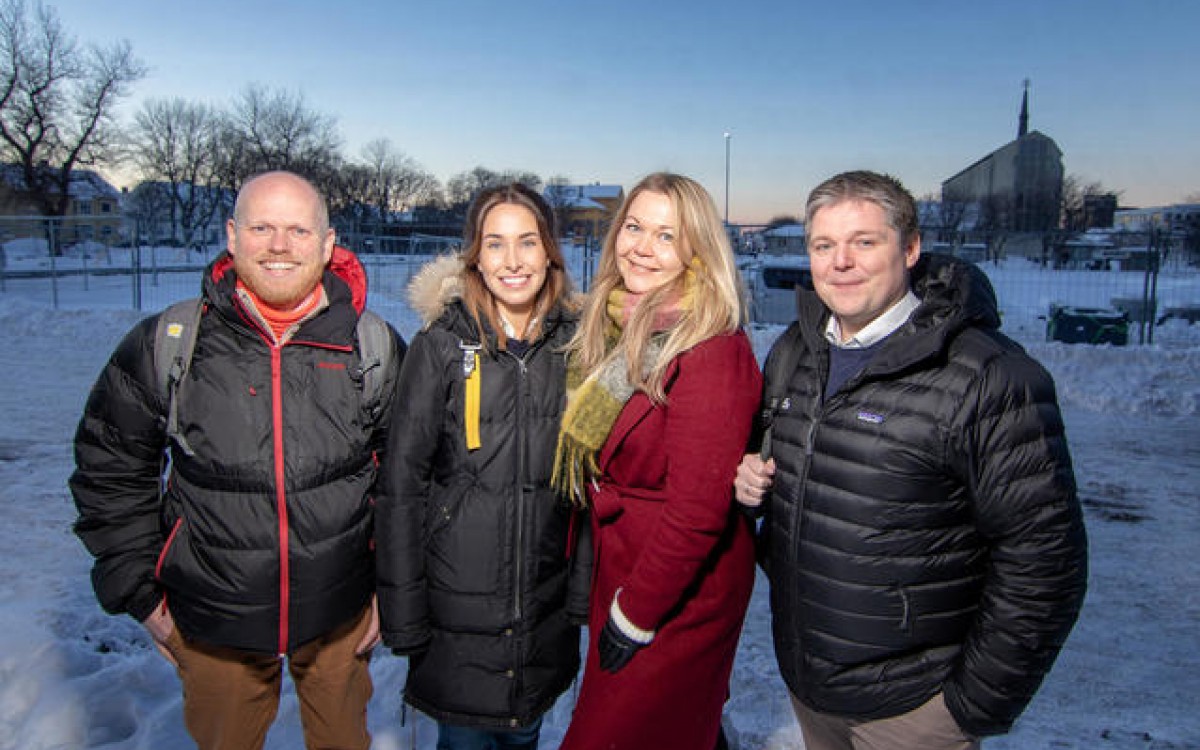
[{"left": 71, "top": 172, "right": 403, "bottom": 749}]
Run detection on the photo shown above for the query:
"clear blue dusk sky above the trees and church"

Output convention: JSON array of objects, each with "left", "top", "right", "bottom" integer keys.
[{"left": 50, "top": 0, "right": 1200, "bottom": 222}]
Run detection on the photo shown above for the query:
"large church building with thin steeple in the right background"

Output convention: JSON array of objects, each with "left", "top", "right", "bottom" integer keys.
[{"left": 942, "top": 79, "right": 1063, "bottom": 232}]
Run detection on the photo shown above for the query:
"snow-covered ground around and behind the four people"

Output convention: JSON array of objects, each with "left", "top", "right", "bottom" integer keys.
[{"left": 0, "top": 244, "right": 1200, "bottom": 750}]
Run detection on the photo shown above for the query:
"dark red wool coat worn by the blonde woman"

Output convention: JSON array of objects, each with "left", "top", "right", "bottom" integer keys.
[{"left": 560, "top": 331, "right": 762, "bottom": 750}]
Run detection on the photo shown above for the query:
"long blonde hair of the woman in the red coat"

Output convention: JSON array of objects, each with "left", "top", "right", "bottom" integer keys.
[{"left": 568, "top": 172, "right": 745, "bottom": 403}]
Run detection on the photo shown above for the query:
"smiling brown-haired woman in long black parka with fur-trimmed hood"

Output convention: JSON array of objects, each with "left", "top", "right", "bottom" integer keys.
[{"left": 376, "top": 184, "right": 590, "bottom": 750}]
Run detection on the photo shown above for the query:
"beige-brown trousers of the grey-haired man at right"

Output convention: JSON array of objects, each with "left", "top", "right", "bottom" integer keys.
[{"left": 792, "top": 692, "right": 979, "bottom": 750}]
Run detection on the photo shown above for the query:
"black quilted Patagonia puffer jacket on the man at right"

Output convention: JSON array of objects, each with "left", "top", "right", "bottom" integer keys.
[{"left": 764, "top": 256, "right": 1087, "bottom": 736}]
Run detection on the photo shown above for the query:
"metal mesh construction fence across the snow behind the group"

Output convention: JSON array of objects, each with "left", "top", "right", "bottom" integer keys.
[{"left": 0, "top": 224, "right": 1200, "bottom": 344}]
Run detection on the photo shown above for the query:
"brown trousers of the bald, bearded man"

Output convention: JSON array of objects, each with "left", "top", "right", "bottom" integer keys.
[{"left": 166, "top": 607, "right": 372, "bottom": 750}]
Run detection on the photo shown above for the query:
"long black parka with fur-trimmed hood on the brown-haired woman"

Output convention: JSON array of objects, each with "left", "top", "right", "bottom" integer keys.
[{"left": 377, "top": 254, "right": 592, "bottom": 728}]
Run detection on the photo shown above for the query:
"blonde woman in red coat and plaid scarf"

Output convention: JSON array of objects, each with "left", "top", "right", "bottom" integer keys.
[{"left": 556, "top": 174, "right": 762, "bottom": 750}]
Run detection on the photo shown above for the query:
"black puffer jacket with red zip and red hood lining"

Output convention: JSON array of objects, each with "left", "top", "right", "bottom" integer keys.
[{"left": 71, "top": 248, "right": 403, "bottom": 653}]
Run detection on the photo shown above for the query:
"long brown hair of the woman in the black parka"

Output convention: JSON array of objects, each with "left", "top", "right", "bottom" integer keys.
[{"left": 462, "top": 182, "right": 571, "bottom": 349}]
